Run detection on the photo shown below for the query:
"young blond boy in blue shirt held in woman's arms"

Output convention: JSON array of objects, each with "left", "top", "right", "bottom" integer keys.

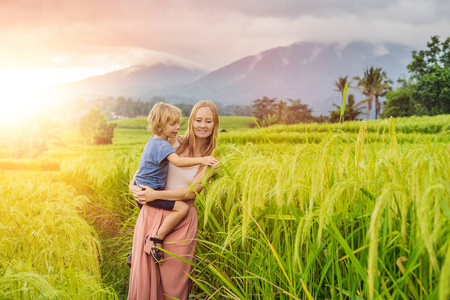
[{"left": 135, "top": 102, "right": 218, "bottom": 264}]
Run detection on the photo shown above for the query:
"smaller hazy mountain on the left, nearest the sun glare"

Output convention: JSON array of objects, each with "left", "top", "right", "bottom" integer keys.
[{"left": 54, "top": 63, "right": 206, "bottom": 100}]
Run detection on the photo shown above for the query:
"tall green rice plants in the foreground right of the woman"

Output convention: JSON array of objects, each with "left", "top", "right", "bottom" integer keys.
[{"left": 194, "top": 120, "right": 450, "bottom": 299}]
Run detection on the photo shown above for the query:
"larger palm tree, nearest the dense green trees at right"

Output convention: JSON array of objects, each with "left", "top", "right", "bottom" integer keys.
[{"left": 353, "top": 67, "right": 392, "bottom": 119}]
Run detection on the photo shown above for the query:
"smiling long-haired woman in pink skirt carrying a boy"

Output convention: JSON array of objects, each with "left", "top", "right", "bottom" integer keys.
[{"left": 128, "top": 101, "right": 219, "bottom": 300}]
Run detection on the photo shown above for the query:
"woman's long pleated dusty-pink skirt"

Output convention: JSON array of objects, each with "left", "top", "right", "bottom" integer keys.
[{"left": 128, "top": 200, "right": 198, "bottom": 300}]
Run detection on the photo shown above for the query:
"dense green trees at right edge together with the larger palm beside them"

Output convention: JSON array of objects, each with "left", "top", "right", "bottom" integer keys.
[{"left": 342, "top": 36, "right": 450, "bottom": 119}]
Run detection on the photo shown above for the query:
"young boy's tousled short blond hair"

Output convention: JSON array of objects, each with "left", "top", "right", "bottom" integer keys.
[{"left": 147, "top": 102, "right": 181, "bottom": 134}]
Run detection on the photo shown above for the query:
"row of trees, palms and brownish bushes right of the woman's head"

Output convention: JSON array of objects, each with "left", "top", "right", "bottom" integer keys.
[{"left": 252, "top": 36, "right": 450, "bottom": 126}]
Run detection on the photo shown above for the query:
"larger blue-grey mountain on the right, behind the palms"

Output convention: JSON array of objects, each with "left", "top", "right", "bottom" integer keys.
[{"left": 168, "top": 42, "right": 411, "bottom": 114}]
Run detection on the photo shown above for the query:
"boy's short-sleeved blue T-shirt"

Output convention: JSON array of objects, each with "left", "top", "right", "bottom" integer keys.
[{"left": 136, "top": 136, "right": 175, "bottom": 190}]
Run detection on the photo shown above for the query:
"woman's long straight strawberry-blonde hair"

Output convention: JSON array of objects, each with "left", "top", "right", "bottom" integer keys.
[{"left": 177, "top": 100, "right": 219, "bottom": 157}]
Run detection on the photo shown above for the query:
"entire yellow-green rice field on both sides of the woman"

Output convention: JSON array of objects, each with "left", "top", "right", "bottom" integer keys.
[{"left": 0, "top": 115, "right": 450, "bottom": 299}]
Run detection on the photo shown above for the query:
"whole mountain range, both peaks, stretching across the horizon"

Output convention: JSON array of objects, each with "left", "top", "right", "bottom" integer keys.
[{"left": 54, "top": 42, "right": 412, "bottom": 115}]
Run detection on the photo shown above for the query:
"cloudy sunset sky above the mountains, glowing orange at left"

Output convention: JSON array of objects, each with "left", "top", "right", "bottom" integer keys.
[{"left": 0, "top": 0, "right": 450, "bottom": 117}]
